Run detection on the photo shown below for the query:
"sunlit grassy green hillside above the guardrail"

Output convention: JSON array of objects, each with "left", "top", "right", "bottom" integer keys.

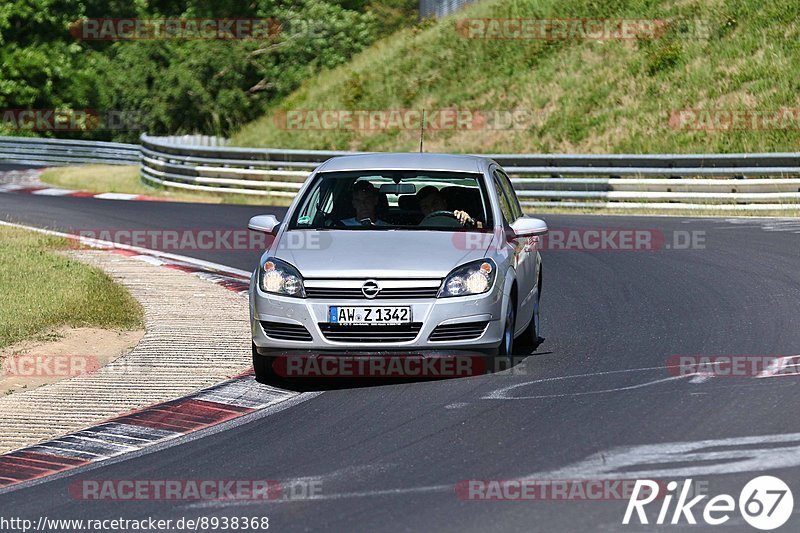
[{"left": 233, "top": 0, "right": 800, "bottom": 153}]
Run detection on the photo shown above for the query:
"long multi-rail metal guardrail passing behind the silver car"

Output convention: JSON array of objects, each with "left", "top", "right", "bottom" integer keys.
[{"left": 141, "top": 135, "right": 800, "bottom": 210}]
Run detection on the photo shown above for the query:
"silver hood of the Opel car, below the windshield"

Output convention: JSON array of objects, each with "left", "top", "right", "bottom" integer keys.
[{"left": 272, "top": 230, "right": 493, "bottom": 279}]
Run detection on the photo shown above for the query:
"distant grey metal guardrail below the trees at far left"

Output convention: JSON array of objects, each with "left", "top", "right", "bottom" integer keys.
[{"left": 0, "top": 137, "right": 139, "bottom": 166}]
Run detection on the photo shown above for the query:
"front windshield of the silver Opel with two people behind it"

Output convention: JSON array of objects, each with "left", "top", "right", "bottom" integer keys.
[{"left": 289, "top": 170, "right": 492, "bottom": 231}]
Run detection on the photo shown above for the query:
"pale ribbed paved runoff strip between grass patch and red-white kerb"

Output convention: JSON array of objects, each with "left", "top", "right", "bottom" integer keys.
[{"left": 0, "top": 250, "right": 251, "bottom": 453}]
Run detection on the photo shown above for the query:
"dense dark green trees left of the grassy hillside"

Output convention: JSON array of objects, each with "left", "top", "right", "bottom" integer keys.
[{"left": 0, "top": 0, "right": 413, "bottom": 141}]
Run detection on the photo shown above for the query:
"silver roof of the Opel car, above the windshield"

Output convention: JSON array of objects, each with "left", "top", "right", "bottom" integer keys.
[{"left": 317, "top": 152, "right": 492, "bottom": 172}]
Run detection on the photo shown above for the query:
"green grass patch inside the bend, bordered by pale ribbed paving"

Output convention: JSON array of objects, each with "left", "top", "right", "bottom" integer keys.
[{"left": 0, "top": 226, "right": 144, "bottom": 348}]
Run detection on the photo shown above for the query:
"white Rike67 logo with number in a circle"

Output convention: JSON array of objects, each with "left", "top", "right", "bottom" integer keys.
[{"left": 622, "top": 476, "right": 794, "bottom": 530}]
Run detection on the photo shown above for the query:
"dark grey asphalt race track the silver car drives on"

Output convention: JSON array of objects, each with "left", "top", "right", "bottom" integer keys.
[{"left": 0, "top": 182, "right": 800, "bottom": 531}]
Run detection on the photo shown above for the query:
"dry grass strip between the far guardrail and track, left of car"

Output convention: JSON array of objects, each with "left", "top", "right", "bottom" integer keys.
[{"left": 40, "top": 165, "right": 288, "bottom": 205}]
